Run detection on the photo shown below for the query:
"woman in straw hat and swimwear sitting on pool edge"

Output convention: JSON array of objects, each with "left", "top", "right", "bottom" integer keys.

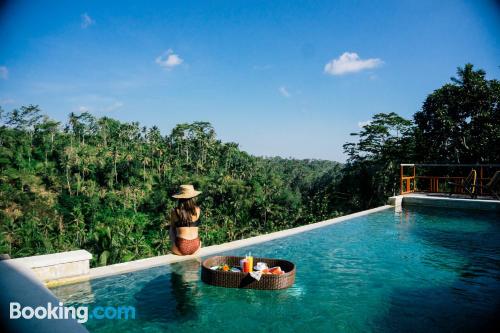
[{"left": 170, "top": 185, "right": 201, "bottom": 256}]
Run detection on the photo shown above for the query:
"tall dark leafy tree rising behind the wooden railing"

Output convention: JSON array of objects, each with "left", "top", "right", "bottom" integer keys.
[{"left": 414, "top": 64, "right": 500, "bottom": 163}]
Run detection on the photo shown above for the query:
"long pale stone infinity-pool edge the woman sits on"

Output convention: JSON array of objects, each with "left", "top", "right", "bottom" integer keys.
[{"left": 46, "top": 205, "right": 394, "bottom": 287}]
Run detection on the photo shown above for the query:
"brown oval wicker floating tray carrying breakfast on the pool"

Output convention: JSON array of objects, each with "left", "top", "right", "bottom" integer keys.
[{"left": 201, "top": 256, "right": 295, "bottom": 290}]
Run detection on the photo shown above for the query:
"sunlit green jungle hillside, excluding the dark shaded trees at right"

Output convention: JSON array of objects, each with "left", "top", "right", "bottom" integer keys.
[{"left": 0, "top": 105, "right": 340, "bottom": 265}]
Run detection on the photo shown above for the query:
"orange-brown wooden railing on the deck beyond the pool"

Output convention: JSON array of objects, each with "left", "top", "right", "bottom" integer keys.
[{"left": 400, "top": 164, "right": 500, "bottom": 195}]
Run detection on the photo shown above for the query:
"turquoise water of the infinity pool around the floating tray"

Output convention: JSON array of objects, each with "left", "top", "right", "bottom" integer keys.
[{"left": 53, "top": 208, "right": 500, "bottom": 333}]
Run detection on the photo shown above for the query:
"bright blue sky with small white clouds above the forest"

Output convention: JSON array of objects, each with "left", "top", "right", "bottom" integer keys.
[{"left": 0, "top": 0, "right": 500, "bottom": 161}]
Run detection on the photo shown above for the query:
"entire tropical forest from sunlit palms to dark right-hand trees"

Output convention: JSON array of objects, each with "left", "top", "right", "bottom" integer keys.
[{"left": 0, "top": 64, "right": 500, "bottom": 267}]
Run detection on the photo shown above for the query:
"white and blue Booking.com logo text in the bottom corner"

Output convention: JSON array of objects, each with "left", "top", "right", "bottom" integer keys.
[{"left": 10, "top": 302, "right": 135, "bottom": 323}]
